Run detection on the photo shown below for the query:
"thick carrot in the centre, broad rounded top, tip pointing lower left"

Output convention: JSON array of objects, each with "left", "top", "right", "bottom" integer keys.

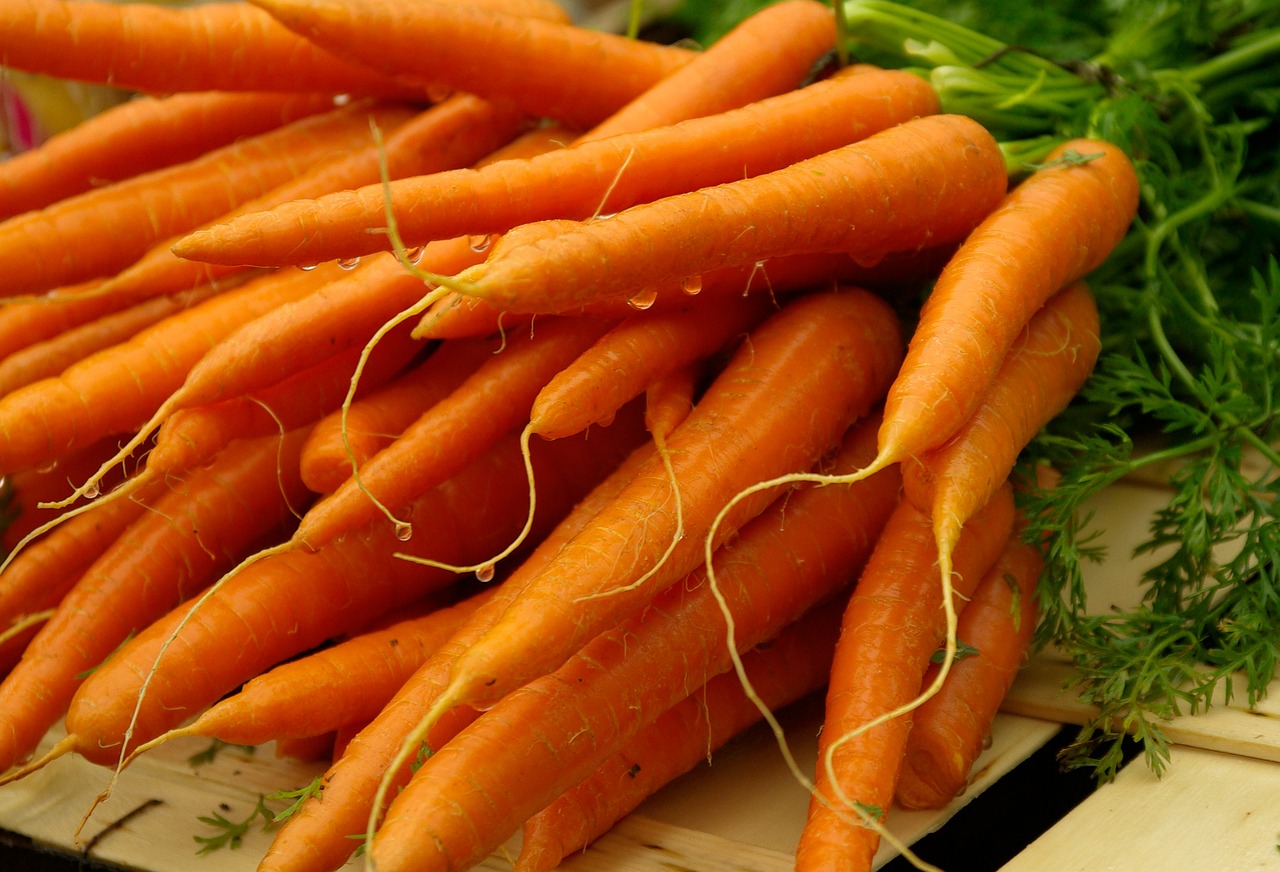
[{"left": 419, "top": 289, "right": 901, "bottom": 720}]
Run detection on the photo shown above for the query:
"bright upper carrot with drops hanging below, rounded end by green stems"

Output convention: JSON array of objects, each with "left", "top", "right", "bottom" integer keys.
[{"left": 432, "top": 113, "right": 1006, "bottom": 311}]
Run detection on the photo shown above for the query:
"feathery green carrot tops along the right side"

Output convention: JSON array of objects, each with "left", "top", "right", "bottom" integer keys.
[{"left": 672, "top": 0, "right": 1280, "bottom": 779}]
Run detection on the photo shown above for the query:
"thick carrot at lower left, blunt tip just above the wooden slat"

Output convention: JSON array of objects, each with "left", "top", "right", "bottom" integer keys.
[{"left": 50, "top": 412, "right": 645, "bottom": 764}]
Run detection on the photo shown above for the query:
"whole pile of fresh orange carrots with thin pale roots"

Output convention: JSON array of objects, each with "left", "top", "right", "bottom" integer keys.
[{"left": 0, "top": 0, "right": 1137, "bottom": 872}]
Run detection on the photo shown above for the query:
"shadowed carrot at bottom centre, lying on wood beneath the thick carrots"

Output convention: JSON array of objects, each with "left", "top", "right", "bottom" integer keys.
[{"left": 513, "top": 601, "right": 841, "bottom": 872}]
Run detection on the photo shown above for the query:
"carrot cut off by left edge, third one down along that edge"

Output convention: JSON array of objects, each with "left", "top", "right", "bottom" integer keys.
[{"left": 0, "top": 104, "right": 411, "bottom": 301}]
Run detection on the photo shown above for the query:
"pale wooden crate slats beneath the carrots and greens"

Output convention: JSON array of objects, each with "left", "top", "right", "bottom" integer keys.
[{"left": 0, "top": 483, "right": 1280, "bottom": 872}]
